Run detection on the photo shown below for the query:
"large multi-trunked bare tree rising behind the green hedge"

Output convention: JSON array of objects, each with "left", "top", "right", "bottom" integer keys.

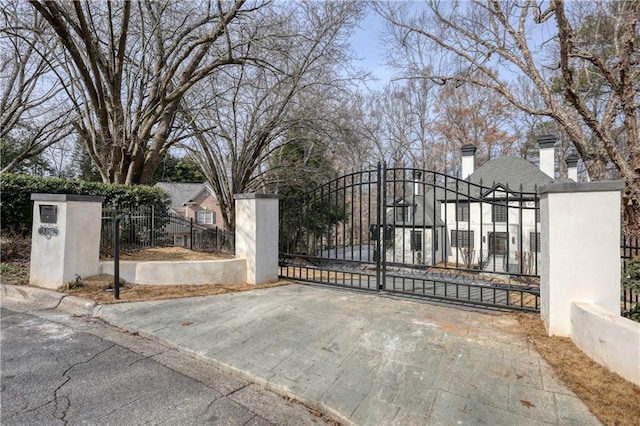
[{"left": 23, "top": 0, "right": 262, "bottom": 184}]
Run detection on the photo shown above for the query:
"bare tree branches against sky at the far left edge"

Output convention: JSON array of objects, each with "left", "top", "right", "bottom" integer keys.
[{"left": 0, "top": 1, "right": 71, "bottom": 173}]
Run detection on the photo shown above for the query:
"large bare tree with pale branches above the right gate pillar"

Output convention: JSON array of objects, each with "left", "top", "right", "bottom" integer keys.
[{"left": 376, "top": 0, "right": 640, "bottom": 236}]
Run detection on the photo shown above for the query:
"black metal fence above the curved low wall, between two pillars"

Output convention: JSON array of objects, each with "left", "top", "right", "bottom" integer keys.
[{"left": 100, "top": 205, "right": 235, "bottom": 257}]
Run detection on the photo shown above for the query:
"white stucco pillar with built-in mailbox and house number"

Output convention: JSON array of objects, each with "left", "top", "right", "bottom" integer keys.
[{"left": 29, "top": 194, "right": 104, "bottom": 289}]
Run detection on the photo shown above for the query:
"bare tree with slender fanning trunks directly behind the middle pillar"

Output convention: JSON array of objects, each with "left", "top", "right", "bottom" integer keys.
[{"left": 184, "top": 2, "right": 363, "bottom": 228}]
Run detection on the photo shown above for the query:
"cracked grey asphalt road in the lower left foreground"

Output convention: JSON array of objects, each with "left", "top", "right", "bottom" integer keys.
[{"left": 0, "top": 305, "right": 336, "bottom": 425}]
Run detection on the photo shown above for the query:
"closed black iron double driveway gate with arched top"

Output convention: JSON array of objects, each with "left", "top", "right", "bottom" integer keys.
[{"left": 279, "top": 164, "right": 540, "bottom": 311}]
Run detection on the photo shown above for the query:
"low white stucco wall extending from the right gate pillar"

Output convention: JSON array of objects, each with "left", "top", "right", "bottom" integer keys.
[{"left": 571, "top": 302, "right": 640, "bottom": 386}]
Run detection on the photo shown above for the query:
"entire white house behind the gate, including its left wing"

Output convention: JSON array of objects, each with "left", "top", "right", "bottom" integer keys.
[{"left": 385, "top": 136, "right": 577, "bottom": 274}]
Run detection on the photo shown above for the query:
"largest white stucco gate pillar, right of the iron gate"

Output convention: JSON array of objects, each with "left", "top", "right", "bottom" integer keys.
[{"left": 539, "top": 181, "right": 624, "bottom": 336}]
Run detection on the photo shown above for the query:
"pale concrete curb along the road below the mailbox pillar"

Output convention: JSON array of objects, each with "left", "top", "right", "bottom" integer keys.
[{"left": 0, "top": 284, "right": 97, "bottom": 315}]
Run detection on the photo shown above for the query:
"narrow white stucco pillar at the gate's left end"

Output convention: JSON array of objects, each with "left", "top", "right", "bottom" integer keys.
[{"left": 234, "top": 194, "right": 279, "bottom": 284}]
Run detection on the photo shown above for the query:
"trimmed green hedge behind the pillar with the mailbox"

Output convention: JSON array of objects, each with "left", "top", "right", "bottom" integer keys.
[{"left": 0, "top": 173, "right": 171, "bottom": 234}]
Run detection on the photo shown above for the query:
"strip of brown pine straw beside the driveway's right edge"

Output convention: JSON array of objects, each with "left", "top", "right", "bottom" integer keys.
[{"left": 518, "top": 314, "right": 640, "bottom": 426}]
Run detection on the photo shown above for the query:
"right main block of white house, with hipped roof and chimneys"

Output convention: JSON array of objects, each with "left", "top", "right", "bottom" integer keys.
[{"left": 438, "top": 136, "right": 577, "bottom": 274}]
